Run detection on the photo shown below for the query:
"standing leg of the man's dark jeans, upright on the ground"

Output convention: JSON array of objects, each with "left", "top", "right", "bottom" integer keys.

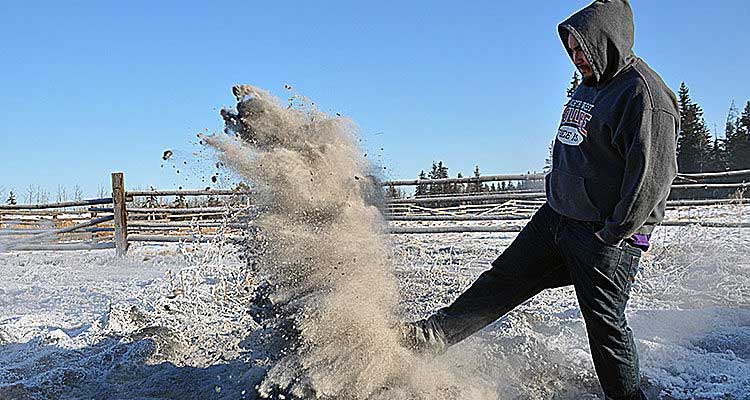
[{"left": 558, "top": 220, "right": 645, "bottom": 399}]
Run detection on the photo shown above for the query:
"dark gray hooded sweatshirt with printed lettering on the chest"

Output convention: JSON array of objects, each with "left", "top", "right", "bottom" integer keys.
[{"left": 546, "top": 0, "right": 680, "bottom": 244}]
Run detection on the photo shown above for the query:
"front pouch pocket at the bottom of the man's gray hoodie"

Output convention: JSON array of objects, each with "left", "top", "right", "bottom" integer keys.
[{"left": 545, "top": 169, "right": 601, "bottom": 221}]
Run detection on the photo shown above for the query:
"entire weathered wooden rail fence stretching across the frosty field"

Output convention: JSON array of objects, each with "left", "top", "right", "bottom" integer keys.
[{"left": 0, "top": 170, "right": 750, "bottom": 255}]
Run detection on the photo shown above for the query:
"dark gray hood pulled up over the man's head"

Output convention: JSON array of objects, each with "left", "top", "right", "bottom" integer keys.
[{"left": 557, "top": 0, "right": 635, "bottom": 86}]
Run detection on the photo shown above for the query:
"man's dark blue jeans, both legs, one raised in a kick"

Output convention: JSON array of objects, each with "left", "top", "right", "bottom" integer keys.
[{"left": 430, "top": 204, "right": 646, "bottom": 399}]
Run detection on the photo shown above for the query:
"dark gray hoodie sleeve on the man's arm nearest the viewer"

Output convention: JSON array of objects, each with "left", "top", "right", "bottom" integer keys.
[{"left": 598, "top": 93, "right": 678, "bottom": 244}]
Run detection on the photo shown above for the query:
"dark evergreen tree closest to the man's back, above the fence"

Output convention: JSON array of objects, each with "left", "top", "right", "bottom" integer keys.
[{"left": 677, "top": 82, "right": 711, "bottom": 172}]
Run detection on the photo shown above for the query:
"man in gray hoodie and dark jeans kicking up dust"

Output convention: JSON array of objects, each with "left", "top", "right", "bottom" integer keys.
[{"left": 403, "top": 0, "right": 679, "bottom": 399}]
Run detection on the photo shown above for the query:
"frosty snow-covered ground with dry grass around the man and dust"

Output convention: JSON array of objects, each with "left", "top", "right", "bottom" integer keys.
[{"left": 0, "top": 206, "right": 750, "bottom": 399}]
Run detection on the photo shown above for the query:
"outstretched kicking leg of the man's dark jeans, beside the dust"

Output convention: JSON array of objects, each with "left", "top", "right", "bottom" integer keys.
[{"left": 431, "top": 204, "right": 571, "bottom": 345}]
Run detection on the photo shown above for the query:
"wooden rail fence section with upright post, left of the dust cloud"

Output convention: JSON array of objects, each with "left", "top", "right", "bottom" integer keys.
[{"left": 0, "top": 173, "right": 251, "bottom": 256}]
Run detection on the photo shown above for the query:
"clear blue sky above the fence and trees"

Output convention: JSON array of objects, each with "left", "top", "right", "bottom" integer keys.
[{"left": 0, "top": 0, "right": 750, "bottom": 200}]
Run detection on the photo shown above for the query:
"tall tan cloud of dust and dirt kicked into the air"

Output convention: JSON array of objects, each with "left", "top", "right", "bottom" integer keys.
[{"left": 204, "top": 85, "right": 494, "bottom": 399}]
